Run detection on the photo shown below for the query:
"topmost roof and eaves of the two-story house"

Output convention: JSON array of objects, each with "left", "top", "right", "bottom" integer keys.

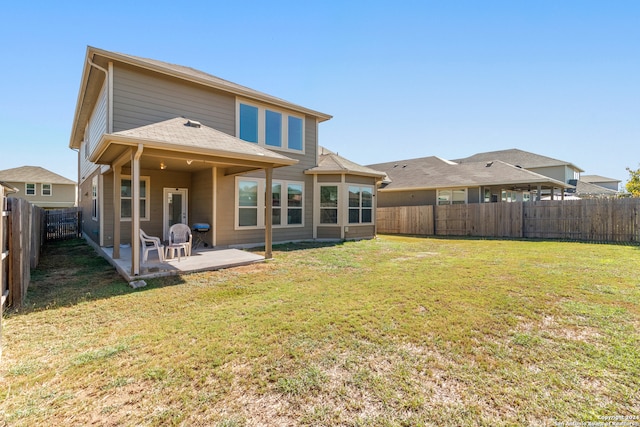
[{"left": 69, "top": 46, "right": 332, "bottom": 148}]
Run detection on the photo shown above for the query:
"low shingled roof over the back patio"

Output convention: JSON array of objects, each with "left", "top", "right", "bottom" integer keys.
[{"left": 90, "top": 117, "right": 298, "bottom": 165}]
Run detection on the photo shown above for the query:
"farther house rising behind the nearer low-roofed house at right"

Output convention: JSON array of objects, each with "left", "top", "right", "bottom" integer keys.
[{"left": 453, "top": 148, "right": 584, "bottom": 184}]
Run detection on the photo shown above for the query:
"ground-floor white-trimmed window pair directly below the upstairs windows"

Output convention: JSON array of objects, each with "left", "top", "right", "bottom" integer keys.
[{"left": 235, "top": 177, "right": 304, "bottom": 229}]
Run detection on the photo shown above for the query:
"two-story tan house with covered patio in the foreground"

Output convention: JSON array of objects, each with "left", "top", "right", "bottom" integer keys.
[{"left": 69, "top": 47, "right": 377, "bottom": 274}]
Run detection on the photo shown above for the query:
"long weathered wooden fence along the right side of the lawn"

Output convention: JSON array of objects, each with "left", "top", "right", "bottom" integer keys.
[{"left": 376, "top": 198, "right": 640, "bottom": 243}]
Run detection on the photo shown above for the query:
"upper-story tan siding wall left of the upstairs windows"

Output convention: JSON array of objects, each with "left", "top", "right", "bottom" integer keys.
[{"left": 113, "top": 66, "right": 235, "bottom": 135}]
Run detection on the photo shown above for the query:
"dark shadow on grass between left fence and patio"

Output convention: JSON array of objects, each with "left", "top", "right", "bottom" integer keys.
[{"left": 5, "top": 239, "right": 183, "bottom": 315}]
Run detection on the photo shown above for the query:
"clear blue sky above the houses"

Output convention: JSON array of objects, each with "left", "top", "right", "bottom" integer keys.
[{"left": 0, "top": 0, "right": 640, "bottom": 187}]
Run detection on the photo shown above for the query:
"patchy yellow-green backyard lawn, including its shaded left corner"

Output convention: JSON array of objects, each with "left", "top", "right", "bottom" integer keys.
[{"left": 0, "top": 236, "right": 640, "bottom": 426}]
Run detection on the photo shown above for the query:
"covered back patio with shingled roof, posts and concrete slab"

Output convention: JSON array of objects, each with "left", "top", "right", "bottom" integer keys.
[{"left": 89, "top": 117, "right": 298, "bottom": 280}]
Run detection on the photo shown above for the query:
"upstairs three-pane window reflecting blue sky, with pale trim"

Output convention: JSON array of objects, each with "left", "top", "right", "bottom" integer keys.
[{"left": 237, "top": 101, "right": 304, "bottom": 152}]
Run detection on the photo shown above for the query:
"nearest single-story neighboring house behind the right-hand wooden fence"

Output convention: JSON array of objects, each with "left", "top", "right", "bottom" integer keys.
[{"left": 368, "top": 156, "right": 571, "bottom": 207}]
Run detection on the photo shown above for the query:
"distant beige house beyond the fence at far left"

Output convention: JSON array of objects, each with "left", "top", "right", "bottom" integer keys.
[{"left": 0, "top": 166, "right": 77, "bottom": 209}]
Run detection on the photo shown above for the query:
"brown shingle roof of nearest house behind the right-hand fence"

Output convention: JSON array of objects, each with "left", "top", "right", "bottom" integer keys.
[{"left": 368, "top": 156, "right": 572, "bottom": 191}]
